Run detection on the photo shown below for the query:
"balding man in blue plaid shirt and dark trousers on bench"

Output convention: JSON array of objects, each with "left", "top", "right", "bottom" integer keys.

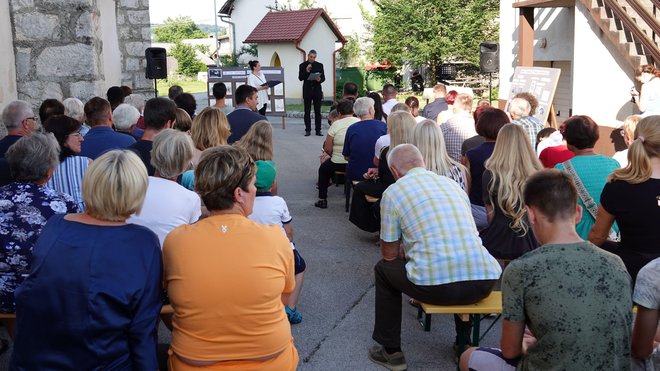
[{"left": 369, "top": 144, "right": 501, "bottom": 370}]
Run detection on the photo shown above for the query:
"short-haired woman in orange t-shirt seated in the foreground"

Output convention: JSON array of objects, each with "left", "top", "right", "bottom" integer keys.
[{"left": 163, "top": 145, "right": 298, "bottom": 371}]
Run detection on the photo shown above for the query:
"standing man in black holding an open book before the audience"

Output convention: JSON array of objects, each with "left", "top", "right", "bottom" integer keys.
[{"left": 298, "top": 49, "right": 325, "bottom": 137}]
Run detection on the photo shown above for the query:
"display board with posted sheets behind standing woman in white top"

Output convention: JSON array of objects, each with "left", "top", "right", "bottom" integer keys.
[{"left": 207, "top": 66, "right": 286, "bottom": 128}]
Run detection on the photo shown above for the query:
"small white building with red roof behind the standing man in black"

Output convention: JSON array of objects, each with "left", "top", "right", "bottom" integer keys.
[{"left": 243, "top": 9, "right": 346, "bottom": 101}]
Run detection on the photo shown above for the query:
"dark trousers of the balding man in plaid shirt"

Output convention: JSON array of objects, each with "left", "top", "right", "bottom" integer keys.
[{"left": 371, "top": 259, "right": 497, "bottom": 348}]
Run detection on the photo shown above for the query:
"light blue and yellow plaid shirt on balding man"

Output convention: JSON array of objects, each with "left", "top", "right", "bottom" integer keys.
[{"left": 380, "top": 168, "right": 502, "bottom": 286}]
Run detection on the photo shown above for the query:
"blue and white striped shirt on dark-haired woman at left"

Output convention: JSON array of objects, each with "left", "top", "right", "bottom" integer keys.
[{"left": 47, "top": 156, "right": 90, "bottom": 212}]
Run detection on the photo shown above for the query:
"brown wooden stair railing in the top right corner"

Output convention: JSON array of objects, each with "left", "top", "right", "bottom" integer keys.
[{"left": 599, "top": 0, "right": 660, "bottom": 67}]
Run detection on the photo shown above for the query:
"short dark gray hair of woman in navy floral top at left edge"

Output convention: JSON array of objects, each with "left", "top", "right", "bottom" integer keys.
[{"left": 5, "top": 133, "right": 60, "bottom": 183}]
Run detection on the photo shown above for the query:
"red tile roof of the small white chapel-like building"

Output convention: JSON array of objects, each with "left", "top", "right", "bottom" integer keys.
[{"left": 243, "top": 9, "right": 346, "bottom": 44}]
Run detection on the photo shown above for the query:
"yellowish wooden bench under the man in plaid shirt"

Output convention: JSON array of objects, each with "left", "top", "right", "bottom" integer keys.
[{"left": 417, "top": 291, "right": 502, "bottom": 356}]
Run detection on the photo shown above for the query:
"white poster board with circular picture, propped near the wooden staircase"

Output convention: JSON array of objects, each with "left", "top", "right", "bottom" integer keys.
[{"left": 506, "top": 67, "right": 561, "bottom": 127}]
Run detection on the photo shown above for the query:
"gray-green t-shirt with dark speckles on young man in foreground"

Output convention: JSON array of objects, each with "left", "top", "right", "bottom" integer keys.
[{"left": 502, "top": 242, "right": 632, "bottom": 370}]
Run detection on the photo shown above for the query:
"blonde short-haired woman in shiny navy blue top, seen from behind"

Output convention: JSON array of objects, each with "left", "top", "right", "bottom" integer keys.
[{"left": 10, "top": 150, "right": 163, "bottom": 370}]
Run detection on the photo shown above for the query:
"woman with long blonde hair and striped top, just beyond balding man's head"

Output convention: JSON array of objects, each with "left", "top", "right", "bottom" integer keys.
[{"left": 411, "top": 120, "right": 468, "bottom": 189}]
